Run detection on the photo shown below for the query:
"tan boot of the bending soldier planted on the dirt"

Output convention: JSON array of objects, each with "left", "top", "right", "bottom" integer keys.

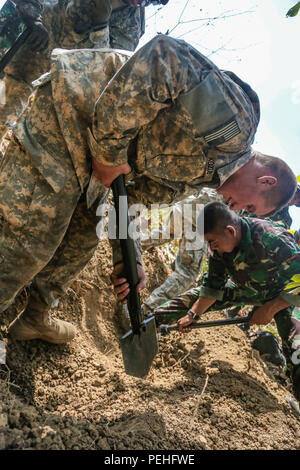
[{"left": 8, "top": 309, "right": 76, "bottom": 344}]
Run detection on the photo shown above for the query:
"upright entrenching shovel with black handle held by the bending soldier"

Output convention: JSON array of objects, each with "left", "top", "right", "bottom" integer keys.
[{"left": 112, "top": 175, "right": 158, "bottom": 378}]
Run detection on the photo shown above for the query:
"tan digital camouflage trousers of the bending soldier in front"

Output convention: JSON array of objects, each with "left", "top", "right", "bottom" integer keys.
[{"left": 0, "top": 134, "right": 108, "bottom": 311}]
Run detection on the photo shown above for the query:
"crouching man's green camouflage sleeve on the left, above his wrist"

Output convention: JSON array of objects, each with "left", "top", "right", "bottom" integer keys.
[{"left": 200, "top": 252, "right": 227, "bottom": 300}]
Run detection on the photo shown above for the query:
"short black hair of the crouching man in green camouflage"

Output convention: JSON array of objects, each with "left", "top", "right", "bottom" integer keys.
[{"left": 203, "top": 202, "right": 241, "bottom": 235}]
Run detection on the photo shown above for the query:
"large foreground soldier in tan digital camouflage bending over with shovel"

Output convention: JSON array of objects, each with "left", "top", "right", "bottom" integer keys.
[{"left": 0, "top": 35, "right": 296, "bottom": 342}]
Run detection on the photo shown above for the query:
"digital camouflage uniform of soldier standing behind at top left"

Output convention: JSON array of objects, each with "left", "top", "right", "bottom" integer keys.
[{"left": 0, "top": 0, "right": 144, "bottom": 136}]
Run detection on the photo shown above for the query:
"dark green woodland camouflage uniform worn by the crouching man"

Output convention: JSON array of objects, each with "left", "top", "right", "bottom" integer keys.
[{"left": 155, "top": 217, "right": 300, "bottom": 400}]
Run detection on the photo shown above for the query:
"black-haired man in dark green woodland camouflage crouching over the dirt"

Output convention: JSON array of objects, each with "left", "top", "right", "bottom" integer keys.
[{"left": 155, "top": 202, "right": 300, "bottom": 400}]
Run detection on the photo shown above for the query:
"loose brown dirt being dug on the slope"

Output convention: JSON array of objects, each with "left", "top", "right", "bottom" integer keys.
[{"left": 0, "top": 242, "right": 300, "bottom": 450}]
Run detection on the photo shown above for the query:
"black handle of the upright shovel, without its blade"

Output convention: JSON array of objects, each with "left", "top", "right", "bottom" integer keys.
[{"left": 111, "top": 175, "right": 143, "bottom": 334}]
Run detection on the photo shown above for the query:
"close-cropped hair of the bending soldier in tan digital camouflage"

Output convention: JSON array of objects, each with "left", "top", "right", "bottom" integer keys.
[{"left": 255, "top": 152, "right": 297, "bottom": 212}]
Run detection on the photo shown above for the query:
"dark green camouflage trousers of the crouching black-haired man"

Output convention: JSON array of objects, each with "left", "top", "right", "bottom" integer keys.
[{"left": 154, "top": 287, "right": 300, "bottom": 401}]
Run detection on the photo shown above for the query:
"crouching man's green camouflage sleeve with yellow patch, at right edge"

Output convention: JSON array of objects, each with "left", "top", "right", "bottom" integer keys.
[{"left": 262, "top": 232, "right": 300, "bottom": 307}]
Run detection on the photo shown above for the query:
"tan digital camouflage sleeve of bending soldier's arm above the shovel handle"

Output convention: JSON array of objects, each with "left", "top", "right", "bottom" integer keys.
[{"left": 89, "top": 35, "right": 206, "bottom": 166}]
